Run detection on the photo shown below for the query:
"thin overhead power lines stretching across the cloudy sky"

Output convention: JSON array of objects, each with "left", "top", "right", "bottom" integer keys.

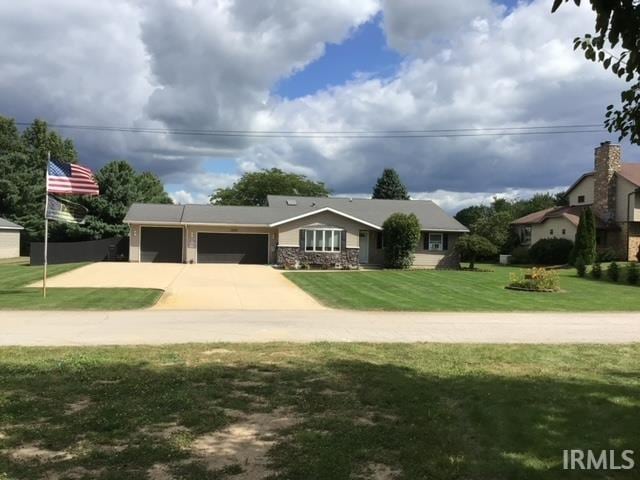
[{"left": 16, "top": 122, "right": 602, "bottom": 139}]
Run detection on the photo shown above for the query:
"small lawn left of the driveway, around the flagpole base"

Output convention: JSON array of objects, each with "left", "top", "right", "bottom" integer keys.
[{"left": 0, "top": 263, "right": 162, "bottom": 310}]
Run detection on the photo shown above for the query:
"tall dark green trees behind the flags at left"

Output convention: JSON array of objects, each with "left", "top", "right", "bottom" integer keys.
[{"left": 0, "top": 116, "right": 171, "bottom": 249}]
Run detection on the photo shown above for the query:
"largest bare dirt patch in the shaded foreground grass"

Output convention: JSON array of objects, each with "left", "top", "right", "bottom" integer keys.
[{"left": 191, "top": 408, "right": 299, "bottom": 480}]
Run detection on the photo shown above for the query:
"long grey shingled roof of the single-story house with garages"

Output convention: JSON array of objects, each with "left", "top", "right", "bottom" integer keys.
[{"left": 124, "top": 195, "right": 468, "bottom": 232}]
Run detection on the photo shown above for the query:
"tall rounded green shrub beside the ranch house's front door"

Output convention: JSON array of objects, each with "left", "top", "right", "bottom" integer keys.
[{"left": 382, "top": 213, "right": 420, "bottom": 268}]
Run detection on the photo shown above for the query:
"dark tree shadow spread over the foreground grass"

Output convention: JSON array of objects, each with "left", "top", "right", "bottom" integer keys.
[{"left": 0, "top": 355, "right": 640, "bottom": 480}]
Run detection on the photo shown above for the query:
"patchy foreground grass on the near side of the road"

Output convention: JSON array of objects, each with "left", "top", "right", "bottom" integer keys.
[{"left": 0, "top": 343, "right": 640, "bottom": 480}]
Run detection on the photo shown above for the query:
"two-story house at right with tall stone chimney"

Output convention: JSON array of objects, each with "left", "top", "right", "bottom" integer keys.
[{"left": 511, "top": 142, "right": 640, "bottom": 260}]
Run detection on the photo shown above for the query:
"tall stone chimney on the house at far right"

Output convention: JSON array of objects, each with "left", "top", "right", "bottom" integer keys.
[{"left": 593, "top": 142, "right": 622, "bottom": 222}]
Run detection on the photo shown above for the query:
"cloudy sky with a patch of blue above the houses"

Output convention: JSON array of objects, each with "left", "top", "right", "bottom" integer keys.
[{"left": 0, "top": 0, "right": 635, "bottom": 211}]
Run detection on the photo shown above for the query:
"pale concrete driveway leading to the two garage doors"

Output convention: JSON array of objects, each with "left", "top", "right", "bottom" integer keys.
[{"left": 31, "top": 262, "right": 324, "bottom": 310}]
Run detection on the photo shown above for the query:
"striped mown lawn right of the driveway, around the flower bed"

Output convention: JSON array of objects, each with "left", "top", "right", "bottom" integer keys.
[{"left": 285, "top": 265, "right": 640, "bottom": 312}]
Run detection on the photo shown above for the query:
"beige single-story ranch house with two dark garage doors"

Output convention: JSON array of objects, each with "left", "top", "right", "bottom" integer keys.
[{"left": 124, "top": 195, "right": 468, "bottom": 268}]
